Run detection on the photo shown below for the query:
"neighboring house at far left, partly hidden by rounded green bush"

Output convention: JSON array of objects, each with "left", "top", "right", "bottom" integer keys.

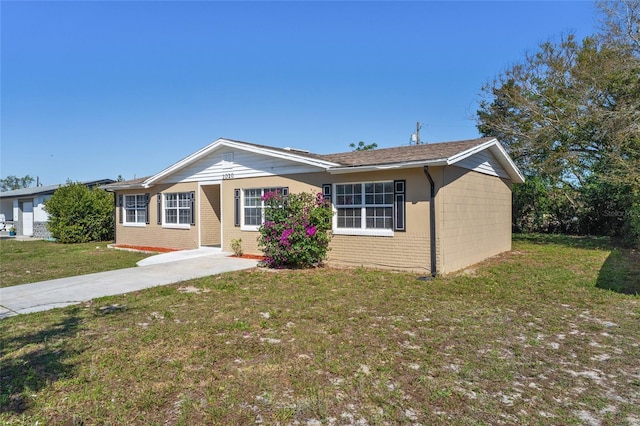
[{"left": 0, "top": 179, "right": 114, "bottom": 238}]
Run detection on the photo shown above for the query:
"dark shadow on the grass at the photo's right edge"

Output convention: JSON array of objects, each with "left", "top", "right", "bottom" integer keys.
[{"left": 596, "top": 248, "right": 640, "bottom": 295}]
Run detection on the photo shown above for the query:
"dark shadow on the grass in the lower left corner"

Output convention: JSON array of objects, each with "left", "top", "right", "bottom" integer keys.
[{"left": 0, "top": 309, "right": 79, "bottom": 413}]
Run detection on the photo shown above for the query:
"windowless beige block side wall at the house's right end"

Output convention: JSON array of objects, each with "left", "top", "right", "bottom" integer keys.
[{"left": 436, "top": 166, "right": 511, "bottom": 274}]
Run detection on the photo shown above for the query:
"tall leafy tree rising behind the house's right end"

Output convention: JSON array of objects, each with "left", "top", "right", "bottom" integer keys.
[{"left": 477, "top": 1, "right": 640, "bottom": 245}]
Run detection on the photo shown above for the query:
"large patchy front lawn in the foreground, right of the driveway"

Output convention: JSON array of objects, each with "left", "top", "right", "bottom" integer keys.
[{"left": 0, "top": 236, "right": 640, "bottom": 425}]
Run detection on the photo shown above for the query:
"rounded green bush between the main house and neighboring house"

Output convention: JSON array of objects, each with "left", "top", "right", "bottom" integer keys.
[{"left": 45, "top": 182, "right": 115, "bottom": 243}]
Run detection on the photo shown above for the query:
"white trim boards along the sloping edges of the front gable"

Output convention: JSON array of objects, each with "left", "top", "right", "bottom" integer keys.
[{"left": 143, "top": 138, "right": 338, "bottom": 188}]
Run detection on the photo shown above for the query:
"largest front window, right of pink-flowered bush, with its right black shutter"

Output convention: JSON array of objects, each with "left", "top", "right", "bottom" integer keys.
[{"left": 328, "top": 181, "right": 404, "bottom": 235}]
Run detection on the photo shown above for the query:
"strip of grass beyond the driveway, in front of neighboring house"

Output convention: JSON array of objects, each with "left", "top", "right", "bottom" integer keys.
[{"left": 0, "top": 240, "right": 154, "bottom": 287}]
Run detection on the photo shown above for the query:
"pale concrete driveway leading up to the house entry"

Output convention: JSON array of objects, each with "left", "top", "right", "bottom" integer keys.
[{"left": 0, "top": 248, "right": 258, "bottom": 319}]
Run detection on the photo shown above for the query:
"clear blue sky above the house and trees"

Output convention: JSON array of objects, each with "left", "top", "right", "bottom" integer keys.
[{"left": 0, "top": 1, "right": 597, "bottom": 184}]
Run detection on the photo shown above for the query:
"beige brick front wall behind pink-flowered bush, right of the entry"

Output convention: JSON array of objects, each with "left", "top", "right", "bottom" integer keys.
[{"left": 222, "top": 168, "right": 430, "bottom": 273}]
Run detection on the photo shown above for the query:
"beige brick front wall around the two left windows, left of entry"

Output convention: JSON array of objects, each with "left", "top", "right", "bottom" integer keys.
[{"left": 115, "top": 183, "right": 200, "bottom": 249}]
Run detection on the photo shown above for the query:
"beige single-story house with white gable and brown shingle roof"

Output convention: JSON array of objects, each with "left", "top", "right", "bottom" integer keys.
[{"left": 103, "top": 138, "right": 524, "bottom": 274}]
